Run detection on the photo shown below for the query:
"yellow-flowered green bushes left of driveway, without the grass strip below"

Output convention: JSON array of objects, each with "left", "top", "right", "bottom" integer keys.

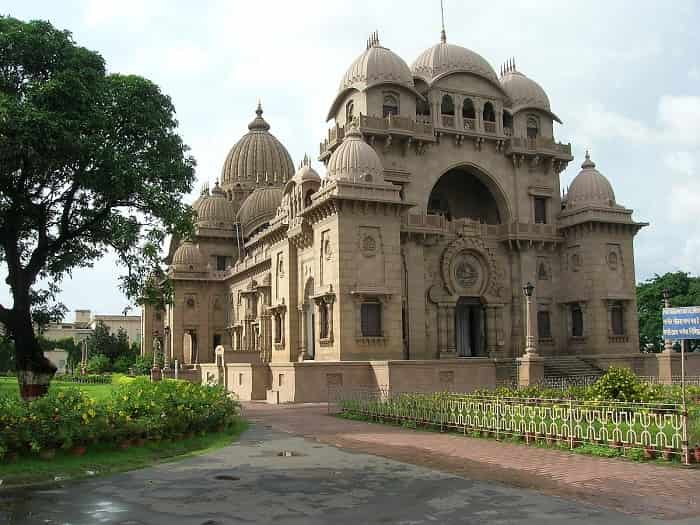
[{"left": 0, "top": 378, "right": 240, "bottom": 456}]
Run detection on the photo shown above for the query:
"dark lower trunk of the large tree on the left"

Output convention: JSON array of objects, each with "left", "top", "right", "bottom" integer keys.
[{"left": 9, "top": 303, "right": 56, "bottom": 401}]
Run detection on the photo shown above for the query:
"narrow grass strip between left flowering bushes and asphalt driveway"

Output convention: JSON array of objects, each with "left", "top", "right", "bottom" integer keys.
[{"left": 0, "top": 418, "right": 247, "bottom": 488}]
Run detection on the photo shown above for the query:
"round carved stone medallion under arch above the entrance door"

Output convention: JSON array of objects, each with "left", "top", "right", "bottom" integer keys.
[{"left": 441, "top": 237, "right": 502, "bottom": 298}]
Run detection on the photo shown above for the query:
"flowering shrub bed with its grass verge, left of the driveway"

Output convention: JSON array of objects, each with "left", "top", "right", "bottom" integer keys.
[{"left": 0, "top": 378, "right": 243, "bottom": 485}]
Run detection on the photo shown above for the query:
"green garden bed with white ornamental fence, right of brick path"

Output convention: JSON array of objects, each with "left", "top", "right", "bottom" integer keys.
[{"left": 335, "top": 369, "right": 700, "bottom": 464}]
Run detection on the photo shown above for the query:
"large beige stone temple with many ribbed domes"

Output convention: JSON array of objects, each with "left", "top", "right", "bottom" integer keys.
[{"left": 142, "top": 31, "right": 645, "bottom": 402}]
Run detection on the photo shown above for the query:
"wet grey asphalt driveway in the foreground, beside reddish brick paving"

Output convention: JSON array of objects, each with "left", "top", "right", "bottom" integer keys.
[{"left": 0, "top": 420, "right": 697, "bottom": 525}]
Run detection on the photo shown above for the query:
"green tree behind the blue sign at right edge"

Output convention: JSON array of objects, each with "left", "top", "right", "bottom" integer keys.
[{"left": 637, "top": 272, "right": 700, "bottom": 352}]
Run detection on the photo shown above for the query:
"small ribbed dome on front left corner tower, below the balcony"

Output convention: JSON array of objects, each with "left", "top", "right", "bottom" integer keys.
[{"left": 328, "top": 126, "right": 384, "bottom": 182}]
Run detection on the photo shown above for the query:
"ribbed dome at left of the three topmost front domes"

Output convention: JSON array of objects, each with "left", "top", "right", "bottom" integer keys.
[{"left": 338, "top": 36, "right": 414, "bottom": 91}]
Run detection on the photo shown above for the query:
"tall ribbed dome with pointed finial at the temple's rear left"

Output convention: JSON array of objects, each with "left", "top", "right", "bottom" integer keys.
[{"left": 221, "top": 104, "right": 294, "bottom": 191}]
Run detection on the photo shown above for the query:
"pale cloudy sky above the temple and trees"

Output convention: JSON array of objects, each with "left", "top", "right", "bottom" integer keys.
[{"left": 0, "top": 0, "right": 700, "bottom": 321}]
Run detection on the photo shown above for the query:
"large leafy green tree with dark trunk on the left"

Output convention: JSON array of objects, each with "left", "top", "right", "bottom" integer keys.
[{"left": 0, "top": 17, "right": 194, "bottom": 399}]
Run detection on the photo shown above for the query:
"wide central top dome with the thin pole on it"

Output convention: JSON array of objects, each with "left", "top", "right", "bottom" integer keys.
[{"left": 411, "top": 40, "right": 500, "bottom": 87}]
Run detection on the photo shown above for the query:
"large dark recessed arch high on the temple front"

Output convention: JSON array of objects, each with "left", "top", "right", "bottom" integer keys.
[{"left": 426, "top": 164, "right": 510, "bottom": 224}]
